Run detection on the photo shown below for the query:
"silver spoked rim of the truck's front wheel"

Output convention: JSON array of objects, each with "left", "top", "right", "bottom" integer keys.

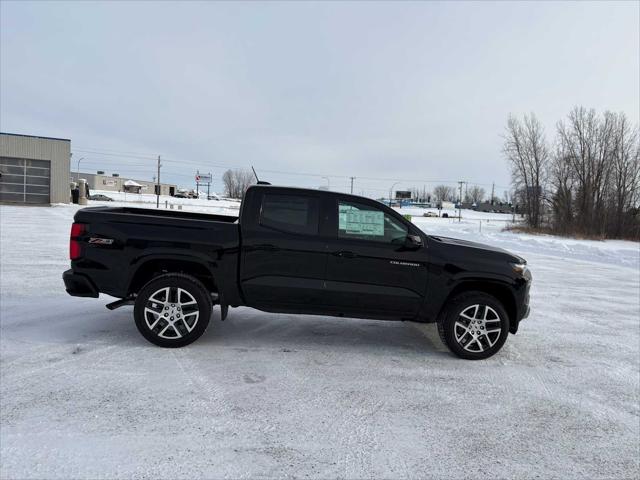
[{"left": 453, "top": 304, "right": 502, "bottom": 353}]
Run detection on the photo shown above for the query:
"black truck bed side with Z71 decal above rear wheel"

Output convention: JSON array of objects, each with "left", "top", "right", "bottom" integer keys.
[{"left": 72, "top": 206, "right": 240, "bottom": 298}]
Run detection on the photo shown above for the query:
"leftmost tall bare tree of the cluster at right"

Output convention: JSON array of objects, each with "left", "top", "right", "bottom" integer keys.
[{"left": 503, "top": 113, "right": 550, "bottom": 228}]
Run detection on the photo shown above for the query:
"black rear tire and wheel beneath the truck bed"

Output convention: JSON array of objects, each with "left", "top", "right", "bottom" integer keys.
[{"left": 133, "top": 273, "right": 213, "bottom": 348}]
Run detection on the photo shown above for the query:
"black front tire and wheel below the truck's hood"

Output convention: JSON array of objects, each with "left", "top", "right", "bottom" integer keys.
[{"left": 438, "top": 292, "right": 509, "bottom": 360}]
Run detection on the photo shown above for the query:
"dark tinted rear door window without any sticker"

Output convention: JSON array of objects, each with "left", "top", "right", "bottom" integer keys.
[{"left": 260, "top": 193, "right": 319, "bottom": 235}]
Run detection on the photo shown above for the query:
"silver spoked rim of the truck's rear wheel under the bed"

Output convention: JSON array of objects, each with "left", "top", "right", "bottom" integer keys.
[{"left": 144, "top": 287, "right": 200, "bottom": 340}]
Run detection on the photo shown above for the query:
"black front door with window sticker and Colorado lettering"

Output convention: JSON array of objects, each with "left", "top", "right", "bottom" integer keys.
[{"left": 325, "top": 197, "right": 427, "bottom": 318}]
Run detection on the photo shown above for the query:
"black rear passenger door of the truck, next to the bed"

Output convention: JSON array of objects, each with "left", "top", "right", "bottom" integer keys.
[{"left": 240, "top": 187, "right": 327, "bottom": 311}]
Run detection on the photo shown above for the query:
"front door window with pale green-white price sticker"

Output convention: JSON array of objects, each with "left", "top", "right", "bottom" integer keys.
[{"left": 338, "top": 201, "right": 409, "bottom": 243}]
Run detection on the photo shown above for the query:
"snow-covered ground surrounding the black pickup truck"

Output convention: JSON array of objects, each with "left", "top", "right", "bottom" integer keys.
[{"left": 0, "top": 199, "right": 640, "bottom": 479}]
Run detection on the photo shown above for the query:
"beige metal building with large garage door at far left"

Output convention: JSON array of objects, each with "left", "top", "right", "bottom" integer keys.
[{"left": 0, "top": 133, "right": 71, "bottom": 205}]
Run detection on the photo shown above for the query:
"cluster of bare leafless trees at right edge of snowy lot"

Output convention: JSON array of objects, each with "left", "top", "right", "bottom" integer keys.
[{"left": 503, "top": 107, "right": 640, "bottom": 239}]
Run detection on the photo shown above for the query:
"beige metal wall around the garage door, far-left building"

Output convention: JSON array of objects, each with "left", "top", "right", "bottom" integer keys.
[{"left": 0, "top": 133, "right": 71, "bottom": 203}]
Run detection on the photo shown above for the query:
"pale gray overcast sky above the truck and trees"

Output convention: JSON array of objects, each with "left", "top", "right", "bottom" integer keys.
[{"left": 0, "top": 1, "right": 640, "bottom": 196}]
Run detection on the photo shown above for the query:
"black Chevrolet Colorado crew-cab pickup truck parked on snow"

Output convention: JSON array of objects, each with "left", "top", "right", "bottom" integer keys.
[{"left": 63, "top": 185, "right": 531, "bottom": 359}]
